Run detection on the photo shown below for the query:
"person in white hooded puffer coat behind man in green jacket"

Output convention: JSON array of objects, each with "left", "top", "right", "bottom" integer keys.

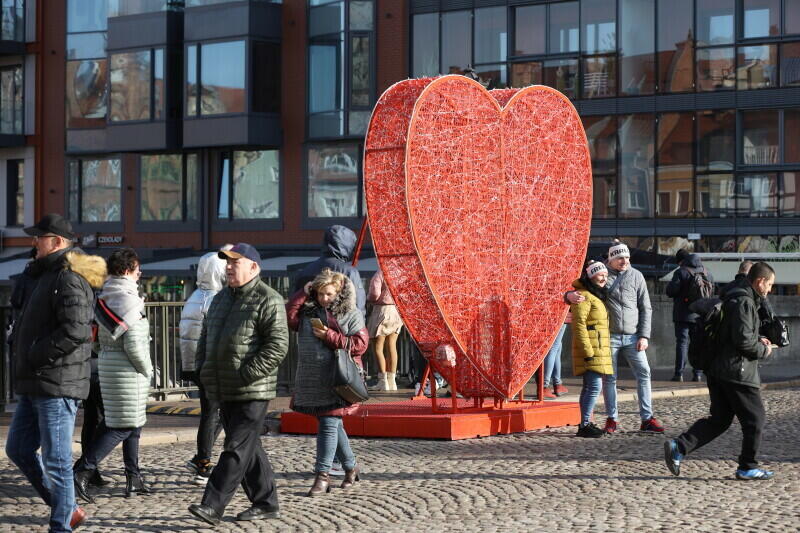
[{"left": 179, "top": 249, "right": 231, "bottom": 484}]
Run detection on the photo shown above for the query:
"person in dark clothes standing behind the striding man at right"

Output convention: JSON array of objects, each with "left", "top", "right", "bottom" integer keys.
[{"left": 666, "top": 250, "right": 714, "bottom": 381}]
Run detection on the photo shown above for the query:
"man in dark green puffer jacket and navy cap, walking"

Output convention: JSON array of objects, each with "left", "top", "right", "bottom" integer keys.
[{"left": 189, "top": 243, "right": 289, "bottom": 525}]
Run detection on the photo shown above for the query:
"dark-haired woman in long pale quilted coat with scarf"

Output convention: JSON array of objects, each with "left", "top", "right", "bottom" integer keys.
[{"left": 75, "top": 248, "right": 153, "bottom": 502}]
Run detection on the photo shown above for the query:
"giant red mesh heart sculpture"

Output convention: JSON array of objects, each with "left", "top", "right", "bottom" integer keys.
[{"left": 364, "top": 76, "right": 592, "bottom": 397}]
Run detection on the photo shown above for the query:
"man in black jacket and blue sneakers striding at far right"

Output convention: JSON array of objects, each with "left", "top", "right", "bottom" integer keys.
[{"left": 664, "top": 263, "right": 775, "bottom": 480}]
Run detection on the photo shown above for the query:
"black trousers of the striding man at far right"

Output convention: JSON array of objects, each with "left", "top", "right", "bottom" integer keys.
[{"left": 675, "top": 378, "right": 766, "bottom": 470}]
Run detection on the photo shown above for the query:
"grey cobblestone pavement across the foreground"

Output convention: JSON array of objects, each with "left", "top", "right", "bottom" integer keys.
[{"left": 0, "top": 389, "right": 800, "bottom": 533}]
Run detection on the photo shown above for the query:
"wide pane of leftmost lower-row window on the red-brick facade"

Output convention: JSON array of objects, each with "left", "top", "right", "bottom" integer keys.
[{"left": 81, "top": 159, "right": 122, "bottom": 222}]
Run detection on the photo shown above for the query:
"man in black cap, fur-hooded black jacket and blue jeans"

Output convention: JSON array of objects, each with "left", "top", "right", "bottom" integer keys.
[{"left": 6, "top": 214, "right": 105, "bottom": 532}]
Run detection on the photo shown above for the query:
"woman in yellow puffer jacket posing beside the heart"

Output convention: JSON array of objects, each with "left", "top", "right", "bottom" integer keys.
[{"left": 571, "top": 261, "right": 614, "bottom": 438}]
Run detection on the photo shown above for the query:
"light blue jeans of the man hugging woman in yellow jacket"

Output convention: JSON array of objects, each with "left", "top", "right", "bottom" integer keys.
[{"left": 603, "top": 333, "right": 653, "bottom": 422}]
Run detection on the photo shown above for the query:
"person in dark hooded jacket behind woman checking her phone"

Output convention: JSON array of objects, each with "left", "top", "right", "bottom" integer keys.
[{"left": 294, "top": 225, "right": 367, "bottom": 316}]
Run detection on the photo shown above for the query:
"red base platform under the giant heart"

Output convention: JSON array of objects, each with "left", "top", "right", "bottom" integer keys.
[{"left": 281, "top": 398, "right": 580, "bottom": 440}]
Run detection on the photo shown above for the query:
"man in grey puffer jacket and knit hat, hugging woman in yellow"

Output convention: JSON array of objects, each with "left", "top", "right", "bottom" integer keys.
[{"left": 567, "top": 240, "right": 664, "bottom": 434}]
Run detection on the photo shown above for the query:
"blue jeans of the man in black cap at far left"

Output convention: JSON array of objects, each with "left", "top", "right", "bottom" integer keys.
[{"left": 6, "top": 395, "right": 78, "bottom": 532}]
